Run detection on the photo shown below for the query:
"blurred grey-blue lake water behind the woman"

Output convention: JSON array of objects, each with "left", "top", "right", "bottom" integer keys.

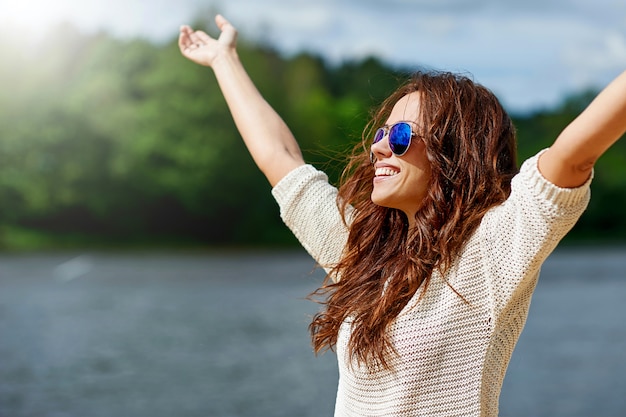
[{"left": 0, "top": 248, "right": 626, "bottom": 417}]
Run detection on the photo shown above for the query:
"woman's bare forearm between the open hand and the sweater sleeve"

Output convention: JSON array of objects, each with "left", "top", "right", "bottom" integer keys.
[{"left": 212, "top": 49, "right": 304, "bottom": 186}]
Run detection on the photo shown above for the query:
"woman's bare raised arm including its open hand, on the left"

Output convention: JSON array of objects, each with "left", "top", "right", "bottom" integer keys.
[{"left": 178, "top": 15, "right": 304, "bottom": 186}]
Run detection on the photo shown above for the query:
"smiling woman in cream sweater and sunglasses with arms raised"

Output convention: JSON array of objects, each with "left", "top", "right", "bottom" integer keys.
[{"left": 179, "top": 16, "right": 626, "bottom": 416}]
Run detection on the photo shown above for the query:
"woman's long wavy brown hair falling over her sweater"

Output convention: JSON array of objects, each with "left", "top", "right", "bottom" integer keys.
[{"left": 309, "top": 72, "right": 518, "bottom": 368}]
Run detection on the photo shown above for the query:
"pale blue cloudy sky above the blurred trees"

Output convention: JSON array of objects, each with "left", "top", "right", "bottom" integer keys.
[{"left": 0, "top": 0, "right": 626, "bottom": 112}]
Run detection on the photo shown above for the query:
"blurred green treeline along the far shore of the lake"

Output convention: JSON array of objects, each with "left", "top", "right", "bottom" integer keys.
[{"left": 0, "top": 22, "right": 626, "bottom": 248}]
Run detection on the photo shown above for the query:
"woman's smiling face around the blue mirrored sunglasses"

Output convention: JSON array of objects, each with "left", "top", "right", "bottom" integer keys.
[{"left": 371, "top": 92, "right": 431, "bottom": 225}]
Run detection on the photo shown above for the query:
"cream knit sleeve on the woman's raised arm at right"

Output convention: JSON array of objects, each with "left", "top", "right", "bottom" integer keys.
[{"left": 479, "top": 151, "right": 591, "bottom": 311}]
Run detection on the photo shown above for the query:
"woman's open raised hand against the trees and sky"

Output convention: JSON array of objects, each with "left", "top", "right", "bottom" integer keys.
[{"left": 178, "top": 15, "right": 237, "bottom": 67}]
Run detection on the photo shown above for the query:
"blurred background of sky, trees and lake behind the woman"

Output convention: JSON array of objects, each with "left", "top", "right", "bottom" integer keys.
[{"left": 0, "top": 0, "right": 626, "bottom": 417}]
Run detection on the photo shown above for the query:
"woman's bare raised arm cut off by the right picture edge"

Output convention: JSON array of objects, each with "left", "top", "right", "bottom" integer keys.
[{"left": 539, "top": 72, "right": 626, "bottom": 188}]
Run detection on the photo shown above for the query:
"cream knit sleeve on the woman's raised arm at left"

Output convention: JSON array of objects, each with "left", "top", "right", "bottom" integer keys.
[{"left": 272, "top": 165, "right": 348, "bottom": 271}]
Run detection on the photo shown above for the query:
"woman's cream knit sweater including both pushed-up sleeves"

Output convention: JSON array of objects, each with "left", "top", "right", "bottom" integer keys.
[{"left": 272, "top": 151, "right": 591, "bottom": 417}]
